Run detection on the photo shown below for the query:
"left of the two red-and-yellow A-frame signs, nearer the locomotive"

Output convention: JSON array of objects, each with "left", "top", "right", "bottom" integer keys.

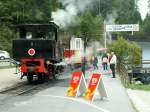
[{"left": 66, "top": 71, "right": 86, "bottom": 97}]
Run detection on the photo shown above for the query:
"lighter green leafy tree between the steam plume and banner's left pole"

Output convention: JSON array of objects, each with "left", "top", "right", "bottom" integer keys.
[{"left": 68, "top": 11, "right": 103, "bottom": 40}]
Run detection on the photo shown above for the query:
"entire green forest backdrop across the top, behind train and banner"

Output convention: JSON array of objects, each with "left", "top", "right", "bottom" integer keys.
[{"left": 0, "top": 0, "right": 150, "bottom": 57}]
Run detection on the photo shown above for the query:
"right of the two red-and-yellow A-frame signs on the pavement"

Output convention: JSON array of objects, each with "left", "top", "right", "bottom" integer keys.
[{"left": 84, "top": 73, "right": 107, "bottom": 101}]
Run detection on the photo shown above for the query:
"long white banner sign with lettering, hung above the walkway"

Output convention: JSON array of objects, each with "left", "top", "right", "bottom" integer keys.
[{"left": 106, "top": 24, "right": 139, "bottom": 32}]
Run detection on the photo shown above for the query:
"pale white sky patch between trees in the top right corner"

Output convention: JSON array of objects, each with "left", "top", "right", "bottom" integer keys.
[{"left": 138, "top": 0, "right": 148, "bottom": 19}]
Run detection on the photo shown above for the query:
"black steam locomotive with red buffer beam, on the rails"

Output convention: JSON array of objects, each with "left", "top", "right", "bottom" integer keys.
[{"left": 12, "top": 22, "right": 64, "bottom": 83}]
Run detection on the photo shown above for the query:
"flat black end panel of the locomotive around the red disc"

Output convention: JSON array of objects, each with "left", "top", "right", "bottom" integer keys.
[{"left": 13, "top": 39, "right": 56, "bottom": 61}]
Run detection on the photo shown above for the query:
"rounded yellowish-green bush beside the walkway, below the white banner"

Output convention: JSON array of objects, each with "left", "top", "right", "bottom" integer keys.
[{"left": 108, "top": 37, "right": 141, "bottom": 69}]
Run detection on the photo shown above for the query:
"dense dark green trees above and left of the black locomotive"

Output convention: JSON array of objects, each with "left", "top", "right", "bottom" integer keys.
[{"left": 0, "top": 0, "right": 59, "bottom": 51}]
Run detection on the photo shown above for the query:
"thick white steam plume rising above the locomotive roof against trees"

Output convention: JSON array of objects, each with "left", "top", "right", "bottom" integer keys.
[{"left": 52, "top": 0, "right": 93, "bottom": 27}]
